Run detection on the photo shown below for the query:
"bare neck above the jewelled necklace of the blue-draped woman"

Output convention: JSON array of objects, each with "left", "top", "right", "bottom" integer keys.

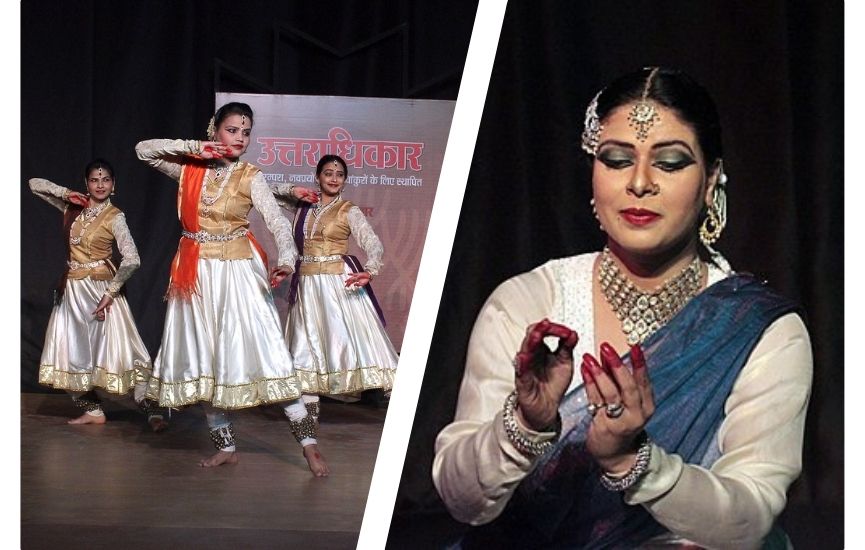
[{"left": 607, "top": 239, "right": 697, "bottom": 291}]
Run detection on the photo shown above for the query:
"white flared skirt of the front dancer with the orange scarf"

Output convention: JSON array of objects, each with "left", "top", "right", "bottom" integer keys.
[{"left": 147, "top": 256, "right": 301, "bottom": 409}]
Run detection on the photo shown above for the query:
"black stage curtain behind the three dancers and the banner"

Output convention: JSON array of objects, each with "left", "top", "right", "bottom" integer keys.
[{"left": 19, "top": 0, "right": 477, "bottom": 391}]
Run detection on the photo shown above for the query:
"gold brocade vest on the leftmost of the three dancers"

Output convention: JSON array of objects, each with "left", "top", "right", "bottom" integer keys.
[{"left": 66, "top": 204, "right": 120, "bottom": 281}]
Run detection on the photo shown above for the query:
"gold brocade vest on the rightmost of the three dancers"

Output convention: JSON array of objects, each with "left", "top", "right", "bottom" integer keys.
[{"left": 300, "top": 199, "right": 354, "bottom": 275}]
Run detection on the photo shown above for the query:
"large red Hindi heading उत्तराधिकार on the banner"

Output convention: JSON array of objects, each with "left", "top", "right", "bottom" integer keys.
[{"left": 256, "top": 127, "right": 424, "bottom": 172}]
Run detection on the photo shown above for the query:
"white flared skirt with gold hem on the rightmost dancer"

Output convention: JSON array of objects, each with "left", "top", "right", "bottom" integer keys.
[{"left": 285, "top": 266, "right": 399, "bottom": 395}]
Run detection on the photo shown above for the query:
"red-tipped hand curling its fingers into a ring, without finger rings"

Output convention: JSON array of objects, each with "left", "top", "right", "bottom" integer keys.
[{"left": 514, "top": 319, "right": 579, "bottom": 431}]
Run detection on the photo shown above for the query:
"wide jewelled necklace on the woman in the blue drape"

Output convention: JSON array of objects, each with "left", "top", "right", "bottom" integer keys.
[{"left": 599, "top": 247, "right": 703, "bottom": 345}]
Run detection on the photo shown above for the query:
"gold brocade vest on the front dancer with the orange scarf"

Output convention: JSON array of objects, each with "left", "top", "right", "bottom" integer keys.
[{"left": 181, "top": 162, "right": 260, "bottom": 260}]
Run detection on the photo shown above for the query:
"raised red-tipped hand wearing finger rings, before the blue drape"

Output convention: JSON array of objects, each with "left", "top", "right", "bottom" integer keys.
[{"left": 580, "top": 342, "right": 655, "bottom": 474}]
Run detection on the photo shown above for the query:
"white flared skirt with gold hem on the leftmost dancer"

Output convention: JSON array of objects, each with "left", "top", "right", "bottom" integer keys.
[{"left": 39, "top": 278, "right": 151, "bottom": 394}]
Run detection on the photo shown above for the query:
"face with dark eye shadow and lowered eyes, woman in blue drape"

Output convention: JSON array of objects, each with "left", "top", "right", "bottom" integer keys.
[{"left": 592, "top": 104, "right": 713, "bottom": 255}]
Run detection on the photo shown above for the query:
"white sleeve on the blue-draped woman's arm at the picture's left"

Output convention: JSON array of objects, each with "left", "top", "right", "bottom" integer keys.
[{"left": 432, "top": 266, "right": 555, "bottom": 525}]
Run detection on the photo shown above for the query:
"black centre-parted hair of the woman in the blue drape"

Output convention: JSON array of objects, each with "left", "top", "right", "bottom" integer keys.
[{"left": 597, "top": 67, "right": 724, "bottom": 171}]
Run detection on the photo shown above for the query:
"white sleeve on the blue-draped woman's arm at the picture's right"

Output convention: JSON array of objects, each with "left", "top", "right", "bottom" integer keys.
[{"left": 625, "top": 313, "right": 812, "bottom": 548}]
